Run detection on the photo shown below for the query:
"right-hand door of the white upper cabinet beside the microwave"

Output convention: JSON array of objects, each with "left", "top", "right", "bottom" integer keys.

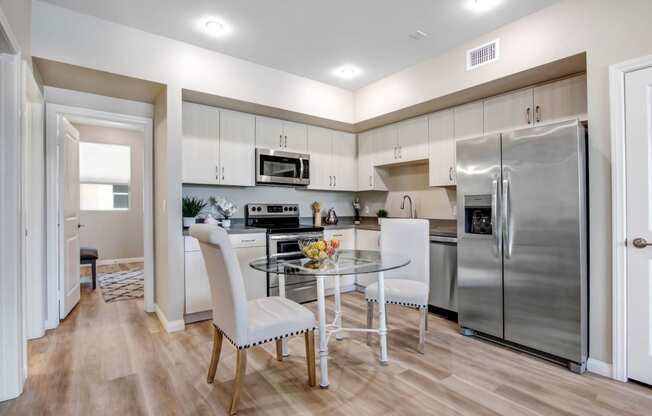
[{"left": 331, "top": 131, "right": 358, "bottom": 191}]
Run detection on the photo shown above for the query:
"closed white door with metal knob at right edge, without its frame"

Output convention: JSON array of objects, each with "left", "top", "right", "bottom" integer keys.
[{"left": 625, "top": 68, "right": 652, "bottom": 384}]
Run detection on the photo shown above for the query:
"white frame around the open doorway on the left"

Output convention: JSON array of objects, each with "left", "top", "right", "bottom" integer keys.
[{"left": 45, "top": 103, "right": 154, "bottom": 329}]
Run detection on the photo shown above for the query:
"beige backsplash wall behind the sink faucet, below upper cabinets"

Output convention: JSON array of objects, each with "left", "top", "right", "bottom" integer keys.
[{"left": 359, "top": 164, "right": 457, "bottom": 220}]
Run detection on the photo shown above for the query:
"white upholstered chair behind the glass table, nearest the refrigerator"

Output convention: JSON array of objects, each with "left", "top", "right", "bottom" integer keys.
[{"left": 365, "top": 219, "right": 430, "bottom": 353}]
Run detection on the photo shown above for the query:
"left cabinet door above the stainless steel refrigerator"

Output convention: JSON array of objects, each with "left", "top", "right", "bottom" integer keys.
[{"left": 484, "top": 88, "right": 534, "bottom": 133}]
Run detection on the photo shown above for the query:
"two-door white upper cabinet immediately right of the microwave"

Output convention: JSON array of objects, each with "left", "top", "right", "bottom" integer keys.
[{"left": 308, "top": 126, "right": 358, "bottom": 191}]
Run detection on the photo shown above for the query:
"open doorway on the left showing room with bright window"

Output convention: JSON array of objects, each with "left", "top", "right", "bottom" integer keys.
[{"left": 46, "top": 104, "right": 154, "bottom": 328}]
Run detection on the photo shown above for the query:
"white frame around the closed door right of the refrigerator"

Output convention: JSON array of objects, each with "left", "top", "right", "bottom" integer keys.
[{"left": 609, "top": 55, "right": 652, "bottom": 382}]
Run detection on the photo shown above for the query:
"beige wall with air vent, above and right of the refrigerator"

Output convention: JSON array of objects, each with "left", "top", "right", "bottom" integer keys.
[{"left": 354, "top": 0, "right": 652, "bottom": 363}]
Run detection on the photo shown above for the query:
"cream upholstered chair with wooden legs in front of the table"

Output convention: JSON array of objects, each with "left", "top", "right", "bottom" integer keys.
[{"left": 190, "top": 224, "right": 316, "bottom": 414}]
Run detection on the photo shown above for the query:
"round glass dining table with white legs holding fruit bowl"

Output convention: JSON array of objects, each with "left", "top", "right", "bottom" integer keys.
[{"left": 249, "top": 250, "right": 410, "bottom": 388}]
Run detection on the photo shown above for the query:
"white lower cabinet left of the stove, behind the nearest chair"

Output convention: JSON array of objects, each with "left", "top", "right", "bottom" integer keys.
[{"left": 184, "top": 234, "right": 267, "bottom": 314}]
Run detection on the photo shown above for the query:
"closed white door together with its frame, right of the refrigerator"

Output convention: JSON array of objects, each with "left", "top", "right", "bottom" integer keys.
[{"left": 610, "top": 56, "right": 652, "bottom": 385}]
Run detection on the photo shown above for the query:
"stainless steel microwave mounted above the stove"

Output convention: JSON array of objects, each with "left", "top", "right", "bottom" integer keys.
[{"left": 256, "top": 148, "right": 310, "bottom": 186}]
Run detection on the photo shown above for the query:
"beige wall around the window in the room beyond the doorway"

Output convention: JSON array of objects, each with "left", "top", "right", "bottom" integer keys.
[{"left": 75, "top": 124, "right": 144, "bottom": 260}]
